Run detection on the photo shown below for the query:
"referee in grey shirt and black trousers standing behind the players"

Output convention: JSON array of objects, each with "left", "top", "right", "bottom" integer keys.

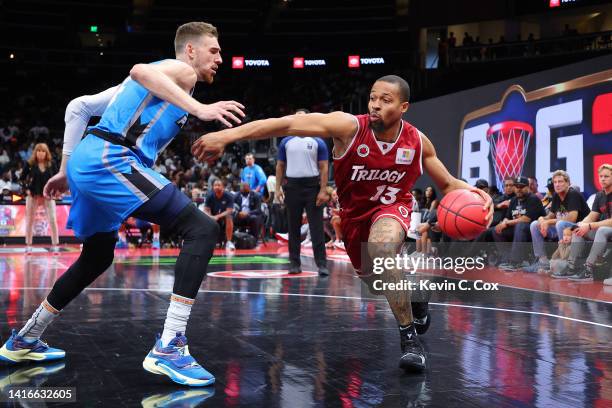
[{"left": 275, "top": 109, "right": 329, "bottom": 276}]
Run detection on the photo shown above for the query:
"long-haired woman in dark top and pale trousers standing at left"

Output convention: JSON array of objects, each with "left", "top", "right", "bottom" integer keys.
[{"left": 21, "top": 143, "right": 59, "bottom": 253}]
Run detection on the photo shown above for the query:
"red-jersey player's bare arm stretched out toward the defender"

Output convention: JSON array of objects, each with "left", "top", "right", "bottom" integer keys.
[{"left": 191, "top": 112, "right": 358, "bottom": 161}]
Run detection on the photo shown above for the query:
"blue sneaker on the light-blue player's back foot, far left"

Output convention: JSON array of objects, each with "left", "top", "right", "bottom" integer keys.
[{"left": 0, "top": 329, "right": 66, "bottom": 363}]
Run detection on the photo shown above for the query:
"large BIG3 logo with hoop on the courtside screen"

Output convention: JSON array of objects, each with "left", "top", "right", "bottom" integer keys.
[{"left": 459, "top": 69, "right": 612, "bottom": 194}]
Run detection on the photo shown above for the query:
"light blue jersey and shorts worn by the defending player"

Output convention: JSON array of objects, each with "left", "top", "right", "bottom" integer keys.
[{"left": 66, "top": 61, "right": 189, "bottom": 238}]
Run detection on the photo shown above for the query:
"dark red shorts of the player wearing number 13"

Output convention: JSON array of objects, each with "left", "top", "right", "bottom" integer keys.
[{"left": 341, "top": 201, "right": 412, "bottom": 273}]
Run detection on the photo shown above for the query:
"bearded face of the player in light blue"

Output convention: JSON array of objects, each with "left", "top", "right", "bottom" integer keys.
[{"left": 184, "top": 35, "right": 223, "bottom": 84}]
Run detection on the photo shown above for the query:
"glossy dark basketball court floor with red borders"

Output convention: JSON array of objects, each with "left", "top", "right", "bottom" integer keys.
[{"left": 0, "top": 243, "right": 612, "bottom": 408}]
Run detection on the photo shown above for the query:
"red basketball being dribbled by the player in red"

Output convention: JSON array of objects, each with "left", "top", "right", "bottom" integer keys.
[{"left": 438, "top": 189, "right": 488, "bottom": 240}]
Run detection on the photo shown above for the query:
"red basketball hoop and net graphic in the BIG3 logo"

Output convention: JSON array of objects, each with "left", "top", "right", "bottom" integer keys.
[{"left": 487, "top": 121, "right": 533, "bottom": 191}]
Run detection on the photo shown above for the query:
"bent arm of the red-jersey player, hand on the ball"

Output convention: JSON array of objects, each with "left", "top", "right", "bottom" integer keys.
[{"left": 421, "top": 135, "right": 493, "bottom": 221}]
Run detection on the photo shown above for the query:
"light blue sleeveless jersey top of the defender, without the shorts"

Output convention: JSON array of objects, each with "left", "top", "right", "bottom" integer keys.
[{"left": 88, "top": 61, "right": 187, "bottom": 167}]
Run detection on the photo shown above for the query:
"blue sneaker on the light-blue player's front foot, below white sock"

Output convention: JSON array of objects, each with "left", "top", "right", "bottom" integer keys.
[{"left": 142, "top": 333, "right": 215, "bottom": 387}]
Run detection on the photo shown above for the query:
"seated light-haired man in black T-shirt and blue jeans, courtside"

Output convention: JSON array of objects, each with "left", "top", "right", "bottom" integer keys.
[{"left": 525, "top": 170, "right": 589, "bottom": 272}]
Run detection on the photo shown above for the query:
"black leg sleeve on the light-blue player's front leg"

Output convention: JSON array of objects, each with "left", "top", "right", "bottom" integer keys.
[{"left": 173, "top": 204, "right": 219, "bottom": 299}]
